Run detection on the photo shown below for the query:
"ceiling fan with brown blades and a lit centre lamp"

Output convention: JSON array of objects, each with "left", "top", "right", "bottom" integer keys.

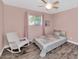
[{"left": 39, "top": 0, "right": 59, "bottom": 10}]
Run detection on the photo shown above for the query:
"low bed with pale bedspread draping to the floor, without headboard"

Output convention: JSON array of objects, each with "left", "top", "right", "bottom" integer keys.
[{"left": 34, "top": 30, "right": 67, "bottom": 57}]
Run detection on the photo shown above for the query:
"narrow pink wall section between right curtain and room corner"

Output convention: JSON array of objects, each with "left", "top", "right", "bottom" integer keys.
[{"left": 44, "top": 15, "right": 54, "bottom": 35}]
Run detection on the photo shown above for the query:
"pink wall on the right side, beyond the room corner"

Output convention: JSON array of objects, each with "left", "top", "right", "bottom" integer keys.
[{"left": 52, "top": 7, "right": 78, "bottom": 43}]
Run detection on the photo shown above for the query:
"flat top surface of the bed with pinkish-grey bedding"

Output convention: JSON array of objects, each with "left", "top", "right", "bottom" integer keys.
[{"left": 36, "top": 35, "right": 65, "bottom": 44}]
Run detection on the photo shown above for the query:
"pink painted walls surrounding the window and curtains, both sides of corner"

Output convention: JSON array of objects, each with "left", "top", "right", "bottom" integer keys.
[{"left": 4, "top": 5, "right": 77, "bottom": 44}]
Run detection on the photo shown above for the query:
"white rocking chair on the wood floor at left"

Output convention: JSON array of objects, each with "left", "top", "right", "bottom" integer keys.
[{"left": 6, "top": 32, "right": 29, "bottom": 53}]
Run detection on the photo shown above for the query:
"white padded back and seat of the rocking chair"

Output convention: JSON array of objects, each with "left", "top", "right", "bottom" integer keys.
[{"left": 6, "top": 32, "right": 20, "bottom": 49}]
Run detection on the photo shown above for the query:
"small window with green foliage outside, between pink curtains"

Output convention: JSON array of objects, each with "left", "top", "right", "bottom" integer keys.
[{"left": 28, "top": 15, "right": 42, "bottom": 26}]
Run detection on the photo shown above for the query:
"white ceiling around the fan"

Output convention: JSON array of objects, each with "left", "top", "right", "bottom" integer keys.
[{"left": 3, "top": 0, "right": 78, "bottom": 14}]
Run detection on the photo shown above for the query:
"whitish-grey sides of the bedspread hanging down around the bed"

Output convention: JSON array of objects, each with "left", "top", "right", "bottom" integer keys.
[{"left": 34, "top": 37, "right": 67, "bottom": 57}]
